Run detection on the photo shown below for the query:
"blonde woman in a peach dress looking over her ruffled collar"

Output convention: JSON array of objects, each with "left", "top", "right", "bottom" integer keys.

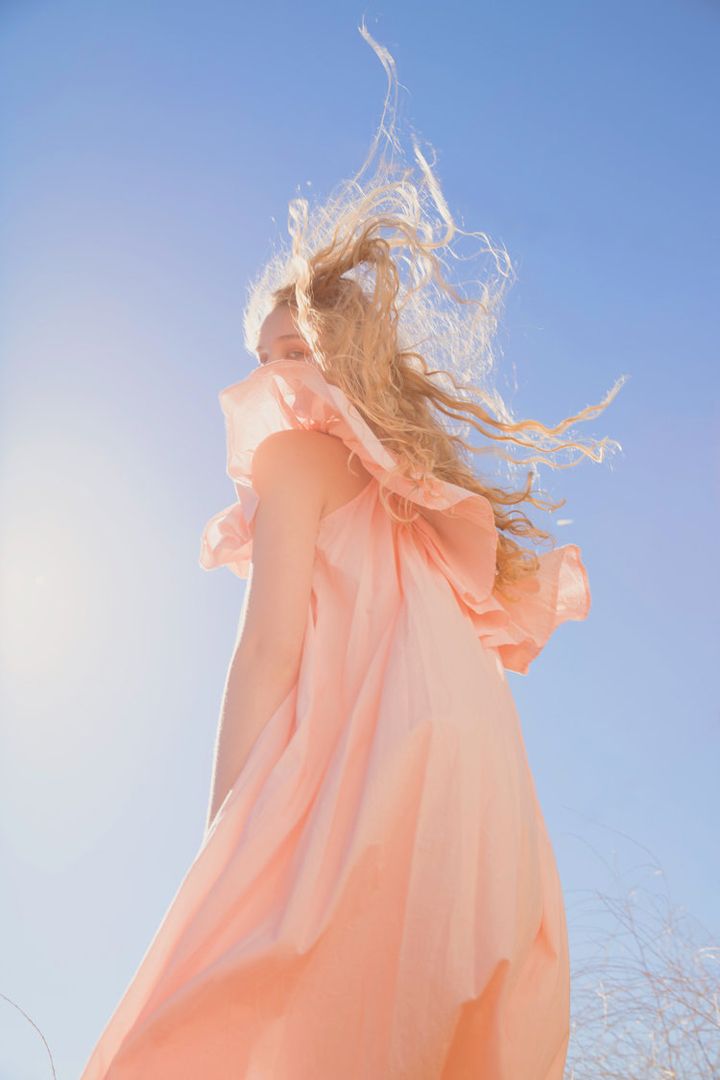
[{"left": 82, "top": 19, "right": 619, "bottom": 1080}]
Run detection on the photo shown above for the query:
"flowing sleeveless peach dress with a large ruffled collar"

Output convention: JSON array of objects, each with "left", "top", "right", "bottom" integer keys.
[{"left": 81, "top": 360, "right": 590, "bottom": 1080}]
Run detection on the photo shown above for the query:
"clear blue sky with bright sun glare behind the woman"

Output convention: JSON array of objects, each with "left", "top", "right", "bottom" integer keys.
[{"left": 0, "top": 0, "right": 720, "bottom": 1080}]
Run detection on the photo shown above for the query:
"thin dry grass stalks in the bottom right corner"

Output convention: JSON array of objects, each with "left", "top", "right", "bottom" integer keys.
[{"left": 566, "top": 833, "right": 720, "bottom": 1080}]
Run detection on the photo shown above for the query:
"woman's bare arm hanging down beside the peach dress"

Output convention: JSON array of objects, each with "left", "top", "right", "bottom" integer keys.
[{"left": 205, "top": 431, "right": 332, "bottom": 831}]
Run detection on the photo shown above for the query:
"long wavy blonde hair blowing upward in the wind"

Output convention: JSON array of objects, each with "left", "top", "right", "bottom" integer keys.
[{"left": 244, "top": 21, "right": 627, "bottom": 595}]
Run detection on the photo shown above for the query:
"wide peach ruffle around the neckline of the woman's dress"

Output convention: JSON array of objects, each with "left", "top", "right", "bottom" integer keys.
[{"left": 200, "top": 360, "right": 590, "bottom": 675}]
